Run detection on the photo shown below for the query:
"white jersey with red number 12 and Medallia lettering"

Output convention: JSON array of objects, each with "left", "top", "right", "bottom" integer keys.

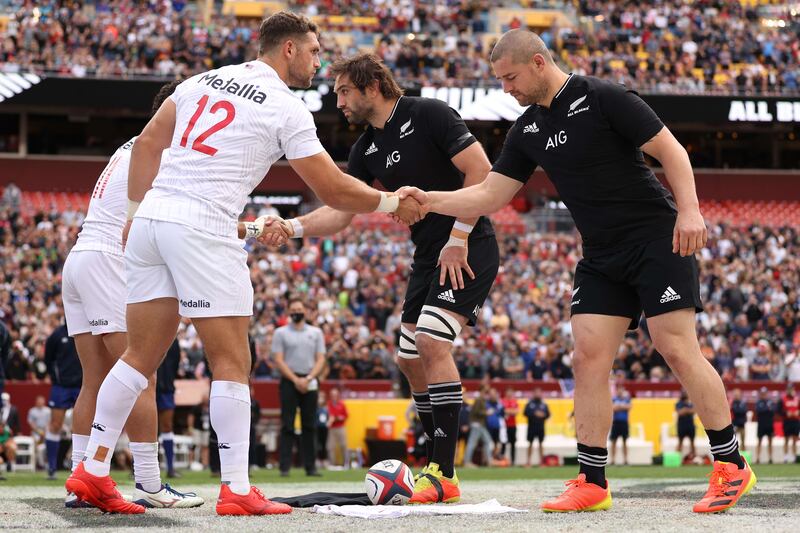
[{"left": 136, "top": 60, "right": 323, "bottom": 236}]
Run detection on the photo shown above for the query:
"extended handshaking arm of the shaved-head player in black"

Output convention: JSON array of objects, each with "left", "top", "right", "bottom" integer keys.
[{"left": 397, "top": 172, "right": 522, "bottom": 217}]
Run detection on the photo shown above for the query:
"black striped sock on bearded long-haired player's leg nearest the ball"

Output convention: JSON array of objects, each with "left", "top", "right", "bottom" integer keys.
[{"left": 428, "top": 381, "right": 464, "bottom": 477}]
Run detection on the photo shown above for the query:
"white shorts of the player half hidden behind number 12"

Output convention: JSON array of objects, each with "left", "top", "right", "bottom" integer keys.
[{"left": 61, "top": 250, "right": 127, "bottom": 336}]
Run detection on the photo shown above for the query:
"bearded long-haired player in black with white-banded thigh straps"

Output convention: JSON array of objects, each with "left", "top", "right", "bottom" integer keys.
[{"left": 276, "top": 54, "right": 499, "bottom": 503}]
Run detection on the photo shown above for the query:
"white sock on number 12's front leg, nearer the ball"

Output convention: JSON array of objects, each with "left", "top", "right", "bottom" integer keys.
[{"left": 209, "top": 381, "right": 250, "bottom": 495}]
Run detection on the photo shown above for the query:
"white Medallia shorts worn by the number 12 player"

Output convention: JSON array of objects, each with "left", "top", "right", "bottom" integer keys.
[{"left": 125, "top": 218, "right": 253, "bottom": 318}]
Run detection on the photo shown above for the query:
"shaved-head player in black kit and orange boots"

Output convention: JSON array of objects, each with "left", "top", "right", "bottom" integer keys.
[{"left": 399, "top": 30, "right": 755, "bottom": 512}]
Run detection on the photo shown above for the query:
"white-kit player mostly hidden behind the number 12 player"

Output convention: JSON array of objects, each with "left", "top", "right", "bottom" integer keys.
[{"left": 62, "top": 82, "right": 203, "bottom": 508}]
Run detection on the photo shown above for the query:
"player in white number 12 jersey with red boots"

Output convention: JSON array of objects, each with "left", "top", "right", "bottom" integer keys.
[{"left": 67, "top": 12, "right": 420, "bottom": 515}]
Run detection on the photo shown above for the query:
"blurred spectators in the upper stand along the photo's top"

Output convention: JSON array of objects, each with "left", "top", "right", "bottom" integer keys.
[{"left": 0, "top": 0, "right": 800, "bottom": 93}]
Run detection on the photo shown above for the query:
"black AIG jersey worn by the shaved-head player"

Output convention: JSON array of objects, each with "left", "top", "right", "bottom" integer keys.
[{"left": 492, "top": 74, "right": 677, "bottom": 257}]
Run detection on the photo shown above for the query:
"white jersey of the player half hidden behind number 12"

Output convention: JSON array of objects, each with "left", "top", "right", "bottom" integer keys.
[{"left": 72, "top": 137, "right": 136, "bottom": 255}]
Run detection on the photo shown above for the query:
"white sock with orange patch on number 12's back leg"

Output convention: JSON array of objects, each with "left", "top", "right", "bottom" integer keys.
[{"left": 84, "top": 359, "right": 147, "bottom": 476}]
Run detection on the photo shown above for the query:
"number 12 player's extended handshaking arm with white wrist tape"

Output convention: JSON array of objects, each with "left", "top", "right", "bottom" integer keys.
[{"left": 289, "top": 151, "right": 424, "bottom": 224}]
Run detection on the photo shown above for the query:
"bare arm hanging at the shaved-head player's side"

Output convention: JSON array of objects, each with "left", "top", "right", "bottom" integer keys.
[{"left": 642, "top": 126, "right": 708, "bottom": 256}]
